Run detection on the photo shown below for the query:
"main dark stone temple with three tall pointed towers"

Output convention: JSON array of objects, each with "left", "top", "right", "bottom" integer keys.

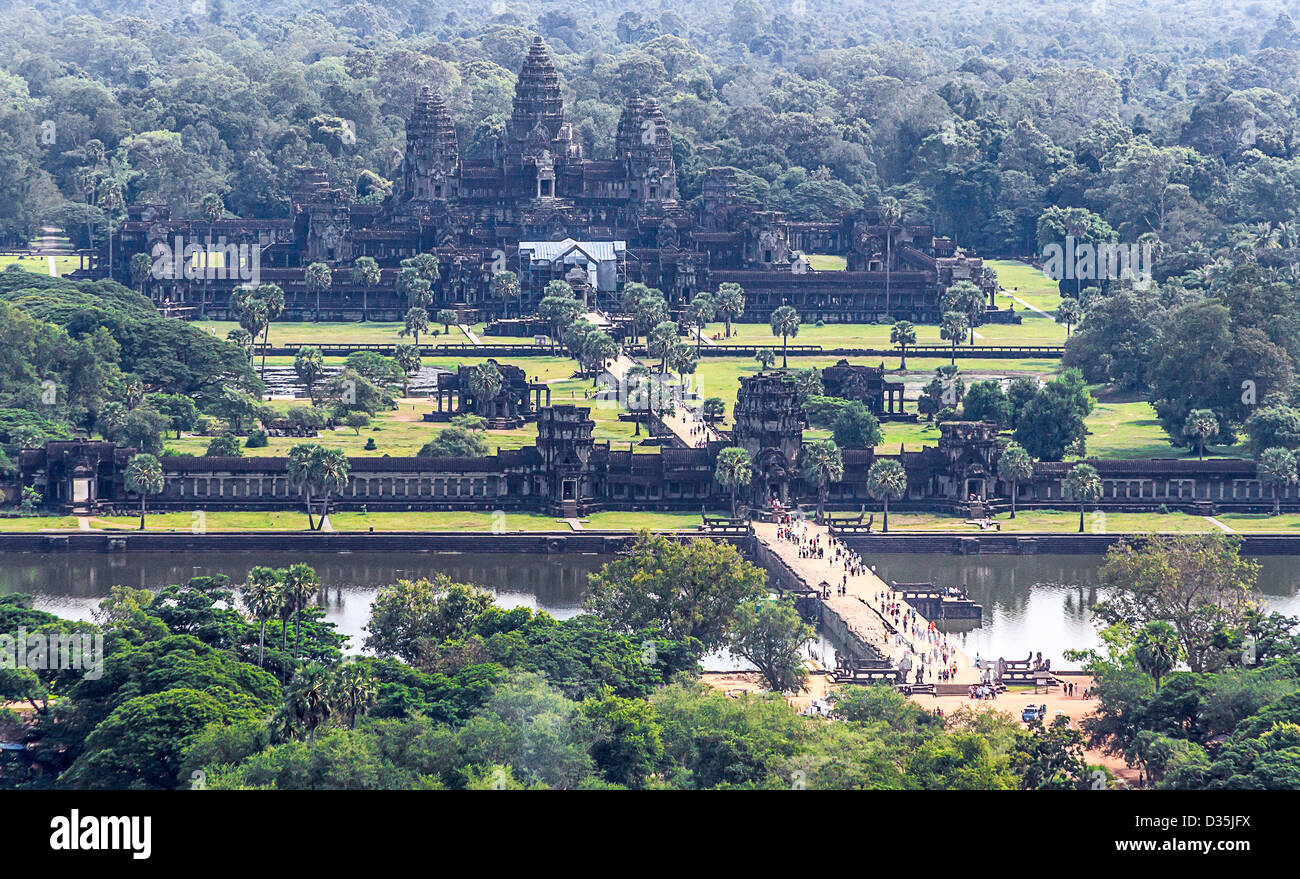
[{"left": 114, "top": 38, "right": 1014, "bottom": 322}]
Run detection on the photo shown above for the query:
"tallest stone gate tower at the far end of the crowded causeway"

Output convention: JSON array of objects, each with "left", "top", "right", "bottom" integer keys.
[{"left": 732, "top": 372, "right": 803, "bottom": 507}]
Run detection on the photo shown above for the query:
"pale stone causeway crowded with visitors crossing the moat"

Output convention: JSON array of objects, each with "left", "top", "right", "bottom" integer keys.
[{"left": 754, "top": 521, "right": 980, "bottom": 684}]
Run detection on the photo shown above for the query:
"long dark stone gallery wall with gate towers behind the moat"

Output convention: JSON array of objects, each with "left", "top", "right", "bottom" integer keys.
[{"left": 12, "top": 372, "right": 1300, "bottom": 516}]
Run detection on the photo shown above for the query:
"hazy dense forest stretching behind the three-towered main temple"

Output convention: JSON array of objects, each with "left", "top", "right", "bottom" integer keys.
[{"left": 0, "top": 0, "right": 1300, "bottom": 261}]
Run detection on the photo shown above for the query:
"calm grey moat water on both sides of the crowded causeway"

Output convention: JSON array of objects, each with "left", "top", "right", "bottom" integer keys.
[{"left": 0, "top": 551, "right": 1300, "bottom": 668}]
